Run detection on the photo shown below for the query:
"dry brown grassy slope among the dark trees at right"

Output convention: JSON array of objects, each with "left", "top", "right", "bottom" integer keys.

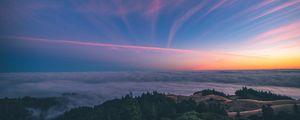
[{"left": 169, "top": 95, "right": 300, "bottom": 117}]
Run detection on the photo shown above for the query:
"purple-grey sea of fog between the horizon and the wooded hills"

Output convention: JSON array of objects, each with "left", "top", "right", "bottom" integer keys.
[{"left": 0, "top": 70, "right": 300, "bottom": 119}]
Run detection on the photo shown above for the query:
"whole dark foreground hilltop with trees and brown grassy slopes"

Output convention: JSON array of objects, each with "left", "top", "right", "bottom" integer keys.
[{"left": 0, "top": 87, "right": 300, "bottom": 120}]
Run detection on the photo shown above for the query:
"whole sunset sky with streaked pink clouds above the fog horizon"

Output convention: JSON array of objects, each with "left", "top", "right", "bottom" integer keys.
[{"left": 0, "top": 0, "right": 300, "bottom": 72}]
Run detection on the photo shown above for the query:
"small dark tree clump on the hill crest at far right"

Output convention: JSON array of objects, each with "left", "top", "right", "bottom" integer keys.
[{"left": 235, "top": 87, "right": 292, "bottom": 100}]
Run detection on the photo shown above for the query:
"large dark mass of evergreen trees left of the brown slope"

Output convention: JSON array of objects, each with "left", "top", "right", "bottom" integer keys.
[{"left": 57, "top": 92, "right": 229, "bottom": 120}]
